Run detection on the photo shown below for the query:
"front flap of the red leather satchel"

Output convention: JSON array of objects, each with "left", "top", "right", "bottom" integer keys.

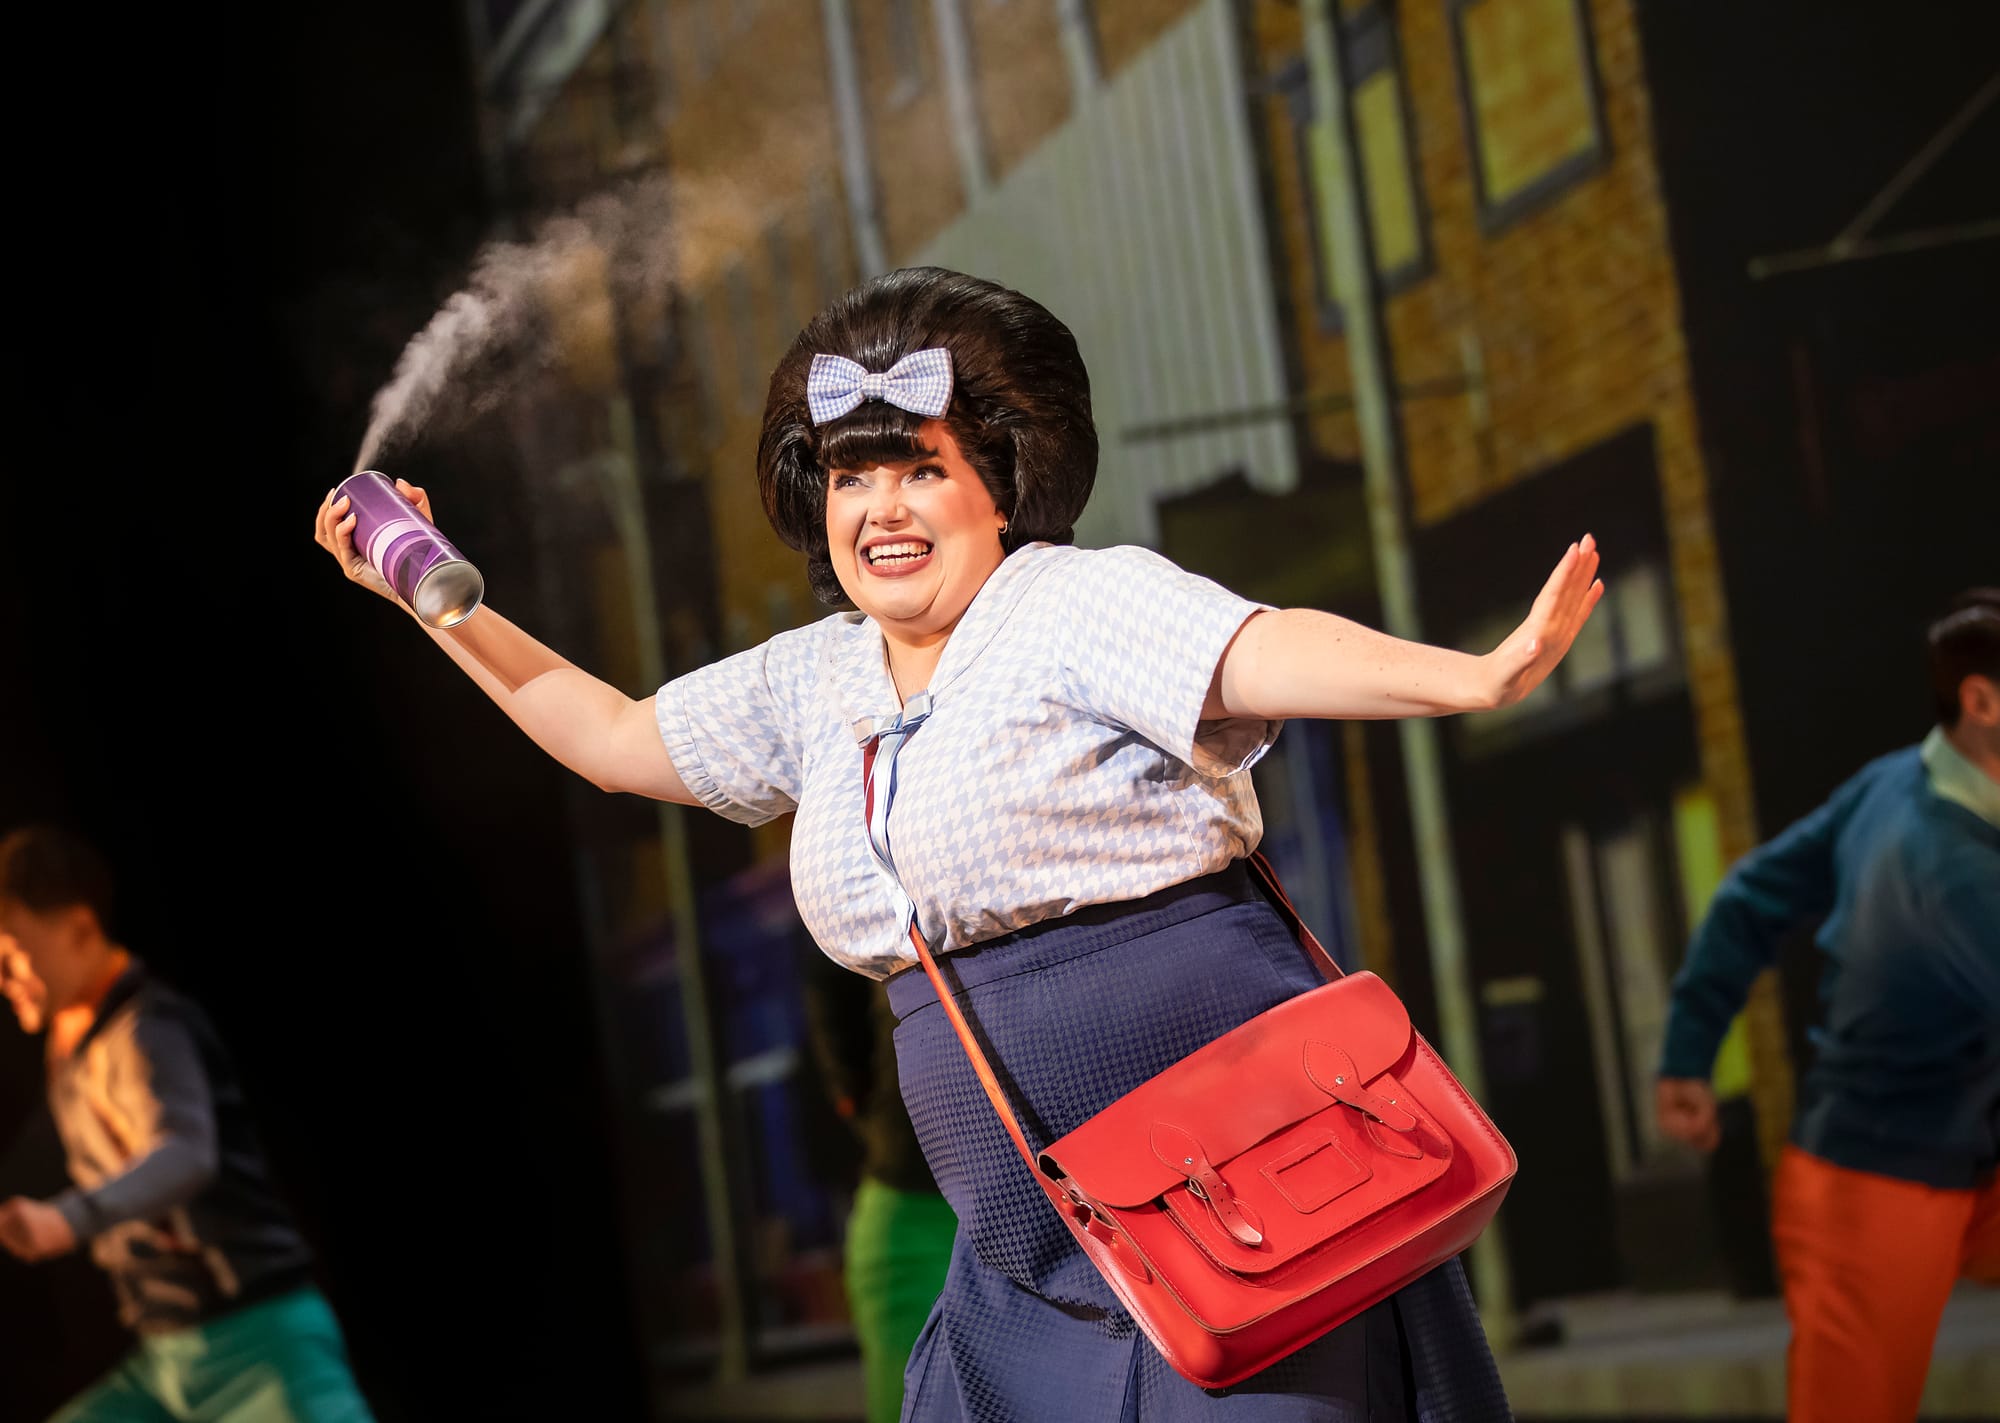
[{"left": 1042, "top": 973, "right": 1410, "bottom": 1205}]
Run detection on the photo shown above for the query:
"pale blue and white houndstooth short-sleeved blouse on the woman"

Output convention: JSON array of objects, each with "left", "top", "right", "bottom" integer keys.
[{"left": 654, "top": 544, "right": 1282, "bottom": 977}]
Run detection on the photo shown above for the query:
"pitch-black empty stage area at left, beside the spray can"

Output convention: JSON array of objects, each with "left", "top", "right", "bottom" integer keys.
[{"left": 0, "top": 4, "right": 642, "bottom": 1423}]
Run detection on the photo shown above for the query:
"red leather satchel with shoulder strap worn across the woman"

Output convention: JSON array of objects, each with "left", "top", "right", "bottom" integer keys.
[{"left": 910, "top": 855, "right": 1514, "bottom": 1389}]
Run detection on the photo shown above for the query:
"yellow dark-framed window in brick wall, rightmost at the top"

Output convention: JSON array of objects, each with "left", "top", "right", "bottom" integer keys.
[{"left": 1450, "top": 0, "right": 1604, "bottom": 230}]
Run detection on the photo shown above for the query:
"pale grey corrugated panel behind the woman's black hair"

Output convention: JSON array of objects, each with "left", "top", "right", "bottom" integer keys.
[{"left": 914, "top": 0, "right": 1298, "bottom": 546}]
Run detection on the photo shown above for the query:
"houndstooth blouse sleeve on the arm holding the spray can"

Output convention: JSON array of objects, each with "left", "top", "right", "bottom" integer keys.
[{"left": 652, "top": 626, "right": 820, "bottom": 825}]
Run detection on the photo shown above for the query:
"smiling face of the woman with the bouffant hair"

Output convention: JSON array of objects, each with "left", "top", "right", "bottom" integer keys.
[{"left": 826, "top": 420, "right": 1006, "bottom": 642}]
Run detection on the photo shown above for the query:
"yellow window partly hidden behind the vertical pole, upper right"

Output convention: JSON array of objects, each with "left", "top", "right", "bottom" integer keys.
[{"left": 1272, "top": 4, "right": 1430, "bottom": 332}]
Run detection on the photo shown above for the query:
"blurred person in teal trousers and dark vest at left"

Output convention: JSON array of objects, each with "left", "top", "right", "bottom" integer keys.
[{"left": 0, "top": 829, "right": 372, "bottom": 1423}]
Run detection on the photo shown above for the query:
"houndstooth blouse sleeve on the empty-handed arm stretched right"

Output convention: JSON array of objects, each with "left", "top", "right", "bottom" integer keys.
[{"left": 1048, "top": 548, "right": 1282, "bottom": 777}]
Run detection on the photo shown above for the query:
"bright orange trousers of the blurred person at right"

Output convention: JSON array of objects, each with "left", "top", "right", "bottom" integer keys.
[{"left": 1772, "top": 1145, "right": 2000, "bottom": 1423}]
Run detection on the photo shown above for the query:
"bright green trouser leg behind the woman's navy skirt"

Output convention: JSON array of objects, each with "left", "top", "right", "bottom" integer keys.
[{"left": 846, "top": 1179, "right": 958, "bottom": 1423}]
